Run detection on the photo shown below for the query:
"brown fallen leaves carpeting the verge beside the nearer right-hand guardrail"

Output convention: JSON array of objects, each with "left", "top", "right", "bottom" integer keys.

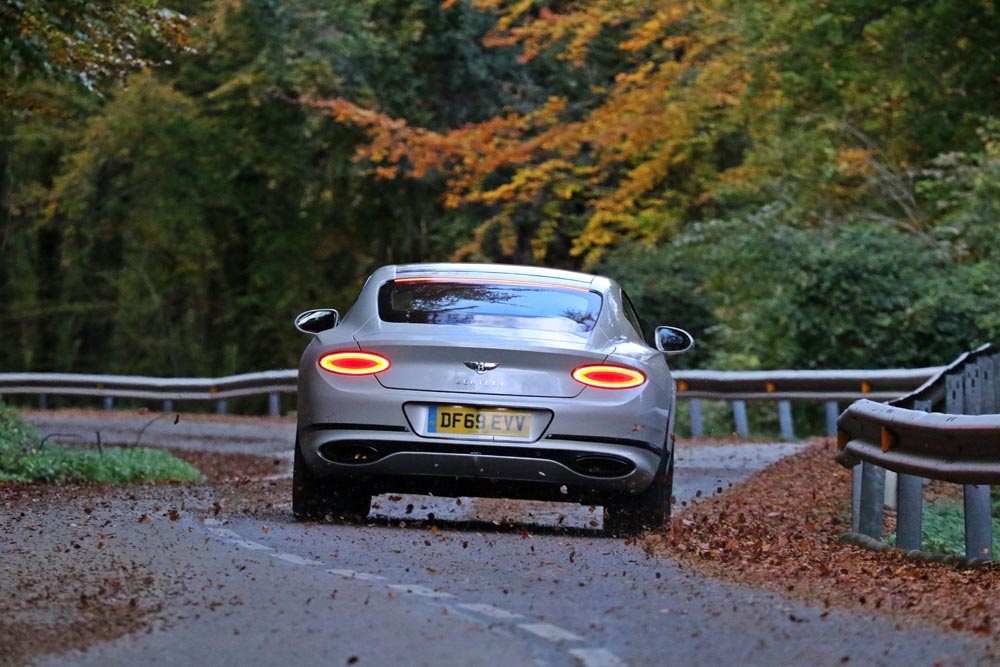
[{"left": 642, "top": 440, "right": 1000, "bottom": 637}]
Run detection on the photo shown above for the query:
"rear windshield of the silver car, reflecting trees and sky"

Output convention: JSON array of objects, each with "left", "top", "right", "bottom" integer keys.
[{"left": 378, "top": 279, "right": 601, "bottom": 333}]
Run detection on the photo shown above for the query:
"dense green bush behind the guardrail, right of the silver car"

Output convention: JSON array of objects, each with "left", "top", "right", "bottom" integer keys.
[{"left": 597, "top": 213, "right": 1000, "bottom": 370}]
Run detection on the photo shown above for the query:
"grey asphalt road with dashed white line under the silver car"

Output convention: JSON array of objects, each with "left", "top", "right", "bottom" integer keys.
[{"left": 19, "top": 416, "right": 994, "bottom": 667}]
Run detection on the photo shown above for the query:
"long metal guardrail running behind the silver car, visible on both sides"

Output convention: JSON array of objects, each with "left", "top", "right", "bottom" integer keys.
[{"left": 0, "top": 367, "right": 941, "bottom": 440}]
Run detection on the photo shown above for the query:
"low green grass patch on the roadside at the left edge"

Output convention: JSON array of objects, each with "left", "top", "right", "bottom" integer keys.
[{"left": 0, "top": 404, "right": 202, "bottom": 484}]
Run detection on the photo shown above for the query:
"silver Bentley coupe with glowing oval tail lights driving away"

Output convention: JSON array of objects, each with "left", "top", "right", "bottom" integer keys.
[{"left": 292, "top": 264, "right": 693, "bottom": 534}]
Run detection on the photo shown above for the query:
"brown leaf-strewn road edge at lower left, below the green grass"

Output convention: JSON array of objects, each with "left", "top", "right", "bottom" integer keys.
[{"left": 0, "top": 451, "right": 278, "bottom": 667}]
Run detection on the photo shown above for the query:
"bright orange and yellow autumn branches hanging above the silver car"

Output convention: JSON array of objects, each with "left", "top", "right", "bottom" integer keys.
[{"left": 306, "top": 0, "right": 748, "bottom": 261}]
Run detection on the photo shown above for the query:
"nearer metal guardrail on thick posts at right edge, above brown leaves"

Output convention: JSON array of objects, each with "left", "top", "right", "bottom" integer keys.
[{"left": 837, "top": 344, "right": 1000, "bottom": 561}]
